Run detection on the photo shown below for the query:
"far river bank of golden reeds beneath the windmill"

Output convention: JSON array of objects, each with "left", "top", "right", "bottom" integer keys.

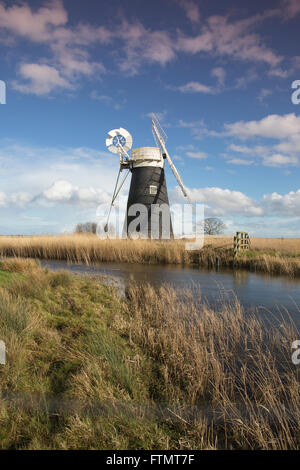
[{"left": 0, "top": 235, "right": 300, "bottom": 277}]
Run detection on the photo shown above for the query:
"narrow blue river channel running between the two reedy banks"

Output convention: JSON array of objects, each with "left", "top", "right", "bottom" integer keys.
[{"left": 42, "top": 261, "right": 300, "bottom": 327}]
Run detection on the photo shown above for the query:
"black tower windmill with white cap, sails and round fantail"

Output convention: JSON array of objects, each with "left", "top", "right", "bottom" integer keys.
[{"left": 104, "top": 114, "right": 192, "bottom": 239}]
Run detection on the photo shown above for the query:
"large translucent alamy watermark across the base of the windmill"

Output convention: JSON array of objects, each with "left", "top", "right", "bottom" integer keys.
[{"left": 96, "top": 204, "right": 204, "bottom": 250}]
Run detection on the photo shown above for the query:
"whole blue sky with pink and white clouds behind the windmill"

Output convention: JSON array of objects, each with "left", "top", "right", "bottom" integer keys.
[{"left": 0, "top": 0, "right": 300, "bottom": 237}]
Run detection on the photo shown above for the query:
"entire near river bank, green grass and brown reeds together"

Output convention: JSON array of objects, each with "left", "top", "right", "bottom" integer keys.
[{"left": 0, "top": 259, "right": 300, "bottom": 449}]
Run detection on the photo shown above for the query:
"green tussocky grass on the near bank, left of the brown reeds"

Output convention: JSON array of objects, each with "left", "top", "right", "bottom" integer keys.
[{"left": 0, "top": 261, "right": 189, "bottom": 449}]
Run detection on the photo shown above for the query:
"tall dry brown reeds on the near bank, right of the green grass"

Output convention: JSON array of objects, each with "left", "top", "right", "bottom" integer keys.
[{"left": 121, "top": 285, "right": 300, "bottom": 449}]
